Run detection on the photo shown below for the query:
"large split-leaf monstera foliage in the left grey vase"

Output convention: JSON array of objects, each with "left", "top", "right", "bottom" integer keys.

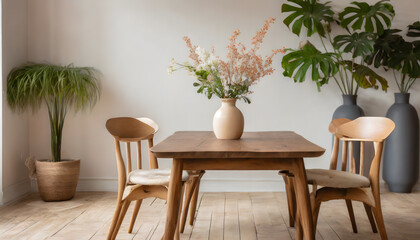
[{"left": 282, "top": 0, "right": 394, "bottom": 95}]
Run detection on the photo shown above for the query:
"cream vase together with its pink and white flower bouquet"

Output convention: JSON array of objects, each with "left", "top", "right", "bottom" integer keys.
[{"left": 168, "top": 18, "right": 284, "bottom": 139}]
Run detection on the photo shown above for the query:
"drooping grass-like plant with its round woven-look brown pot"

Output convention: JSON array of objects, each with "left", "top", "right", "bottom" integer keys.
[{"left": 7, "top": 64, "right": 100, "bottom": 201}]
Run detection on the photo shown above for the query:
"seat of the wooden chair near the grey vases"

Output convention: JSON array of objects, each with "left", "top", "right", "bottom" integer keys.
[{"left": 306, "top": 169, "right": 370, "bottom": 188}]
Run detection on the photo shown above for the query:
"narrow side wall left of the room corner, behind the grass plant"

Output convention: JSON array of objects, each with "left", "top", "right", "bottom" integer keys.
[{"left": 0, "top": 0, "right": 30, "bottom": 203}]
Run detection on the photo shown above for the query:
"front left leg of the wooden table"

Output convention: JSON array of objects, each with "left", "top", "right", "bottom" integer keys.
[{"left": 163, "top": 158, "right": 182, "bottom": 240}]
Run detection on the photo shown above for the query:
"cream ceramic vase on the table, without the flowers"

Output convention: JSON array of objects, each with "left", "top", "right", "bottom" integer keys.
[{"left": 213, "top": 98, "right": 244, "bottom": 139}]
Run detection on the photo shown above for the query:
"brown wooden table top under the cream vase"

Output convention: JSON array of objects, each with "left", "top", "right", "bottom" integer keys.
[{"left": 151, "top": 131, "right": 325, "bottom": 158}]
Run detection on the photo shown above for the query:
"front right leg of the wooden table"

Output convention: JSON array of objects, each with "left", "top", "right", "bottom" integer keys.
[{"left": 293, "top": 158, "right": 315, "bottom": 240}]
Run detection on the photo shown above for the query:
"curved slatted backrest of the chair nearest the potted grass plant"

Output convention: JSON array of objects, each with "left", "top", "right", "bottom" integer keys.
[{"left": 106, "top": 117, "right": 159, "bottom": 184}]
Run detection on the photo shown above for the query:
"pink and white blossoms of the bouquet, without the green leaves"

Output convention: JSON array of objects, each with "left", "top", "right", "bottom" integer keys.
[{"left": 176, "top": 18, "right": 285, "bottom": 98}]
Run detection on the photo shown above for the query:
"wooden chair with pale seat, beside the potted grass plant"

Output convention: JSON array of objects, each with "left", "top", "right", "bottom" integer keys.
[{"left": 106, "top": 117, "right": 204, "bottom": 239}]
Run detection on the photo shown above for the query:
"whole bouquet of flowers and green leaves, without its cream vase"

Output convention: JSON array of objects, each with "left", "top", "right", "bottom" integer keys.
[{"left": 168, "top": 18, "right": 284, "bottom": 103}]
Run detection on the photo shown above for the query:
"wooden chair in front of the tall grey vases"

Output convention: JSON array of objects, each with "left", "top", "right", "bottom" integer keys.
[{"left": 280, "top": 117, "right": 395, "bottom": 240}]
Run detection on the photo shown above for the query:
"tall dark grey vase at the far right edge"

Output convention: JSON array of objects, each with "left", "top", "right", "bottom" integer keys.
[{"left": 383, "top": 93, "right": 419, "bottom": 193}]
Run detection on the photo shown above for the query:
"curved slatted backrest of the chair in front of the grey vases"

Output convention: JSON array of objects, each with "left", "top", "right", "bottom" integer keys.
[{"left": 329, "top": 117, "right": 395, "bottom": 187}]
